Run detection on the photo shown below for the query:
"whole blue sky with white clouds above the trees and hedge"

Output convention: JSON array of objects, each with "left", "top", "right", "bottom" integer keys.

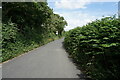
[{"left": 47, "top": 0, "right": 119, "bottom": 31}]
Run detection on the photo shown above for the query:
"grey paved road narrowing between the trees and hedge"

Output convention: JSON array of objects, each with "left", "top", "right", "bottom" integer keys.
[{"left": 2, "top": 39, "right": 81, "bottom": 78}]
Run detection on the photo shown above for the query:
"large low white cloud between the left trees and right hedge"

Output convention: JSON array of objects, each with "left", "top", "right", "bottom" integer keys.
[{"left": 55, "top": 12, "right": 100, "bottom": 31}]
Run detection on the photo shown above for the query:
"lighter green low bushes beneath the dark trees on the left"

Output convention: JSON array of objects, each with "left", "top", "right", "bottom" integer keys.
[{"left": 1, "top": 22, "right": 62, "bottom": 62}]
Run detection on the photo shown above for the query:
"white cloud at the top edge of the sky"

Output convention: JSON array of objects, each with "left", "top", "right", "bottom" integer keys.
[{"left": 55, "top": 0, "right": 90, "bottom": 9}]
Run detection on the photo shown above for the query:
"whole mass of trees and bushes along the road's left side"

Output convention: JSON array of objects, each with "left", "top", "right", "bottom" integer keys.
[{"left": 0, "top": 2, "right": 67, "bottom": 62}]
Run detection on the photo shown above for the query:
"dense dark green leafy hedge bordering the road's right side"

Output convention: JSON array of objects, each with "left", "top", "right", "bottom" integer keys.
[{"left": 64, "top": 17, "right": 120, "bottom": 80}]
